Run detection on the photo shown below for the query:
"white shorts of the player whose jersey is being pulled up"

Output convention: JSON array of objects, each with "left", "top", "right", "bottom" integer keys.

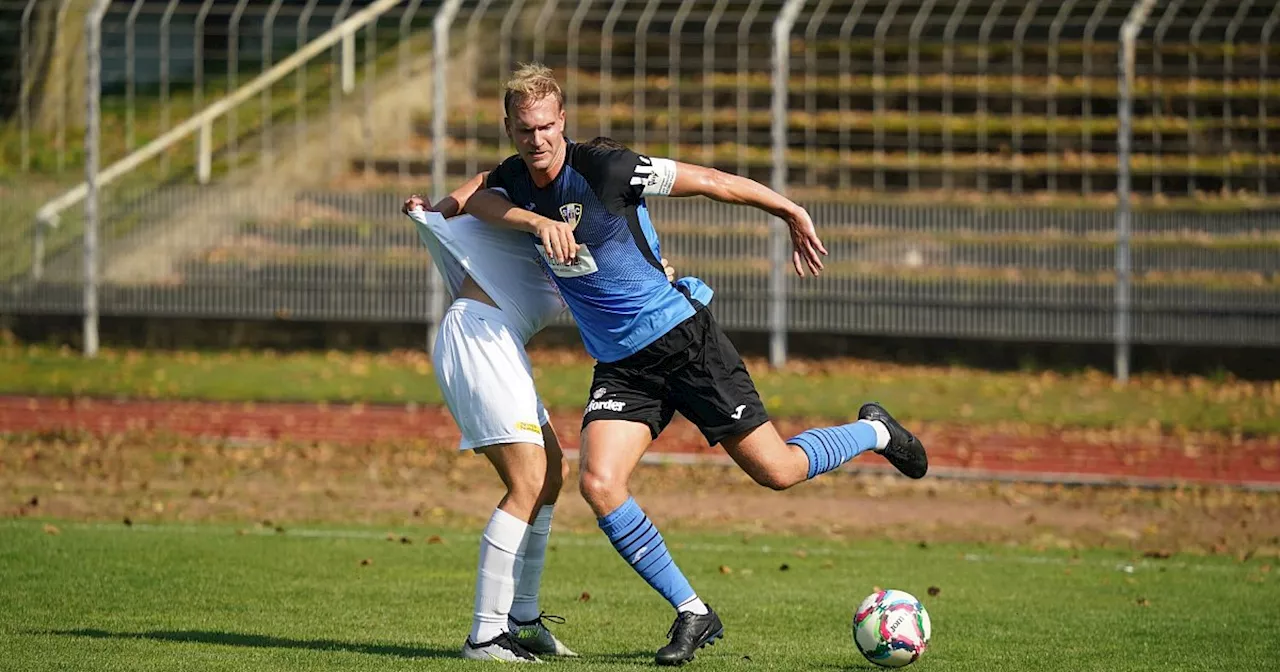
[{"left": 434, "top": 298, "right": 550, "bottom": 451}]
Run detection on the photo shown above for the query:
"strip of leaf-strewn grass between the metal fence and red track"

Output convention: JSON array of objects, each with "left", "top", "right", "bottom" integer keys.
[{"left": 0, "top": 346, "right": 1280, "bottom": 435}]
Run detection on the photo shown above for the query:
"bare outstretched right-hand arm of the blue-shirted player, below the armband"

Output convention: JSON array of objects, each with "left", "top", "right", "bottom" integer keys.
[{"left": 668, "top": 161, "right": 827, "bottom": 278}]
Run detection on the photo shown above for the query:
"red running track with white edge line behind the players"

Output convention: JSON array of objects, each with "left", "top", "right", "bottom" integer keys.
[{"left": 0, "top": 397, "right": 1280, "bottom": 489}]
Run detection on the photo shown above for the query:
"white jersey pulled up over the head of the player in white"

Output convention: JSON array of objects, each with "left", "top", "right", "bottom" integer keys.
[{"left": 408, "top": 210, "right": 564, "bottom": 343}]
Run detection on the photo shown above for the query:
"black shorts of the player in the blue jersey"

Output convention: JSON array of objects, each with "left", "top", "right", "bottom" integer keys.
[{"left": 582, "top": 307, "right": 769, "bottom": 445}]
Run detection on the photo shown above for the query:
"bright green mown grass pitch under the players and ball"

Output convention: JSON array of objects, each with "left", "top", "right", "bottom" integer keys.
[{"left": 0, "top": 520, "right": 1280, "bottom": 672}]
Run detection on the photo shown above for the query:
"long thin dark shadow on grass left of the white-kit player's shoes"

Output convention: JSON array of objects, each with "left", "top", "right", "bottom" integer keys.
[{"left": 40, "top": 628, "right": 458, "bottom": 658}]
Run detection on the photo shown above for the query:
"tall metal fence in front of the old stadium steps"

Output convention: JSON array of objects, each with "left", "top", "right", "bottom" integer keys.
[{"left": 0, "top": 0, "right": 1280, "bottom": 375}]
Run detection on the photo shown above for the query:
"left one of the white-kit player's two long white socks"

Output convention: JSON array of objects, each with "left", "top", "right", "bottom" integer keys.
[{"left": 471, "top": 508, "right": 529, "bottom": 644}]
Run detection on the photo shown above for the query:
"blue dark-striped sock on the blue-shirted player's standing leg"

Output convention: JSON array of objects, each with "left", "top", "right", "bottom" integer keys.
[{"left": 599, "top": 497, "right": 695, "bottom": 608}]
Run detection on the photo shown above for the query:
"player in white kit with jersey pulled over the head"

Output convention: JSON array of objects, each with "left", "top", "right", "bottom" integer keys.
[{"left": 403, "top": 173, "right": 673, "bottom": 663}]
